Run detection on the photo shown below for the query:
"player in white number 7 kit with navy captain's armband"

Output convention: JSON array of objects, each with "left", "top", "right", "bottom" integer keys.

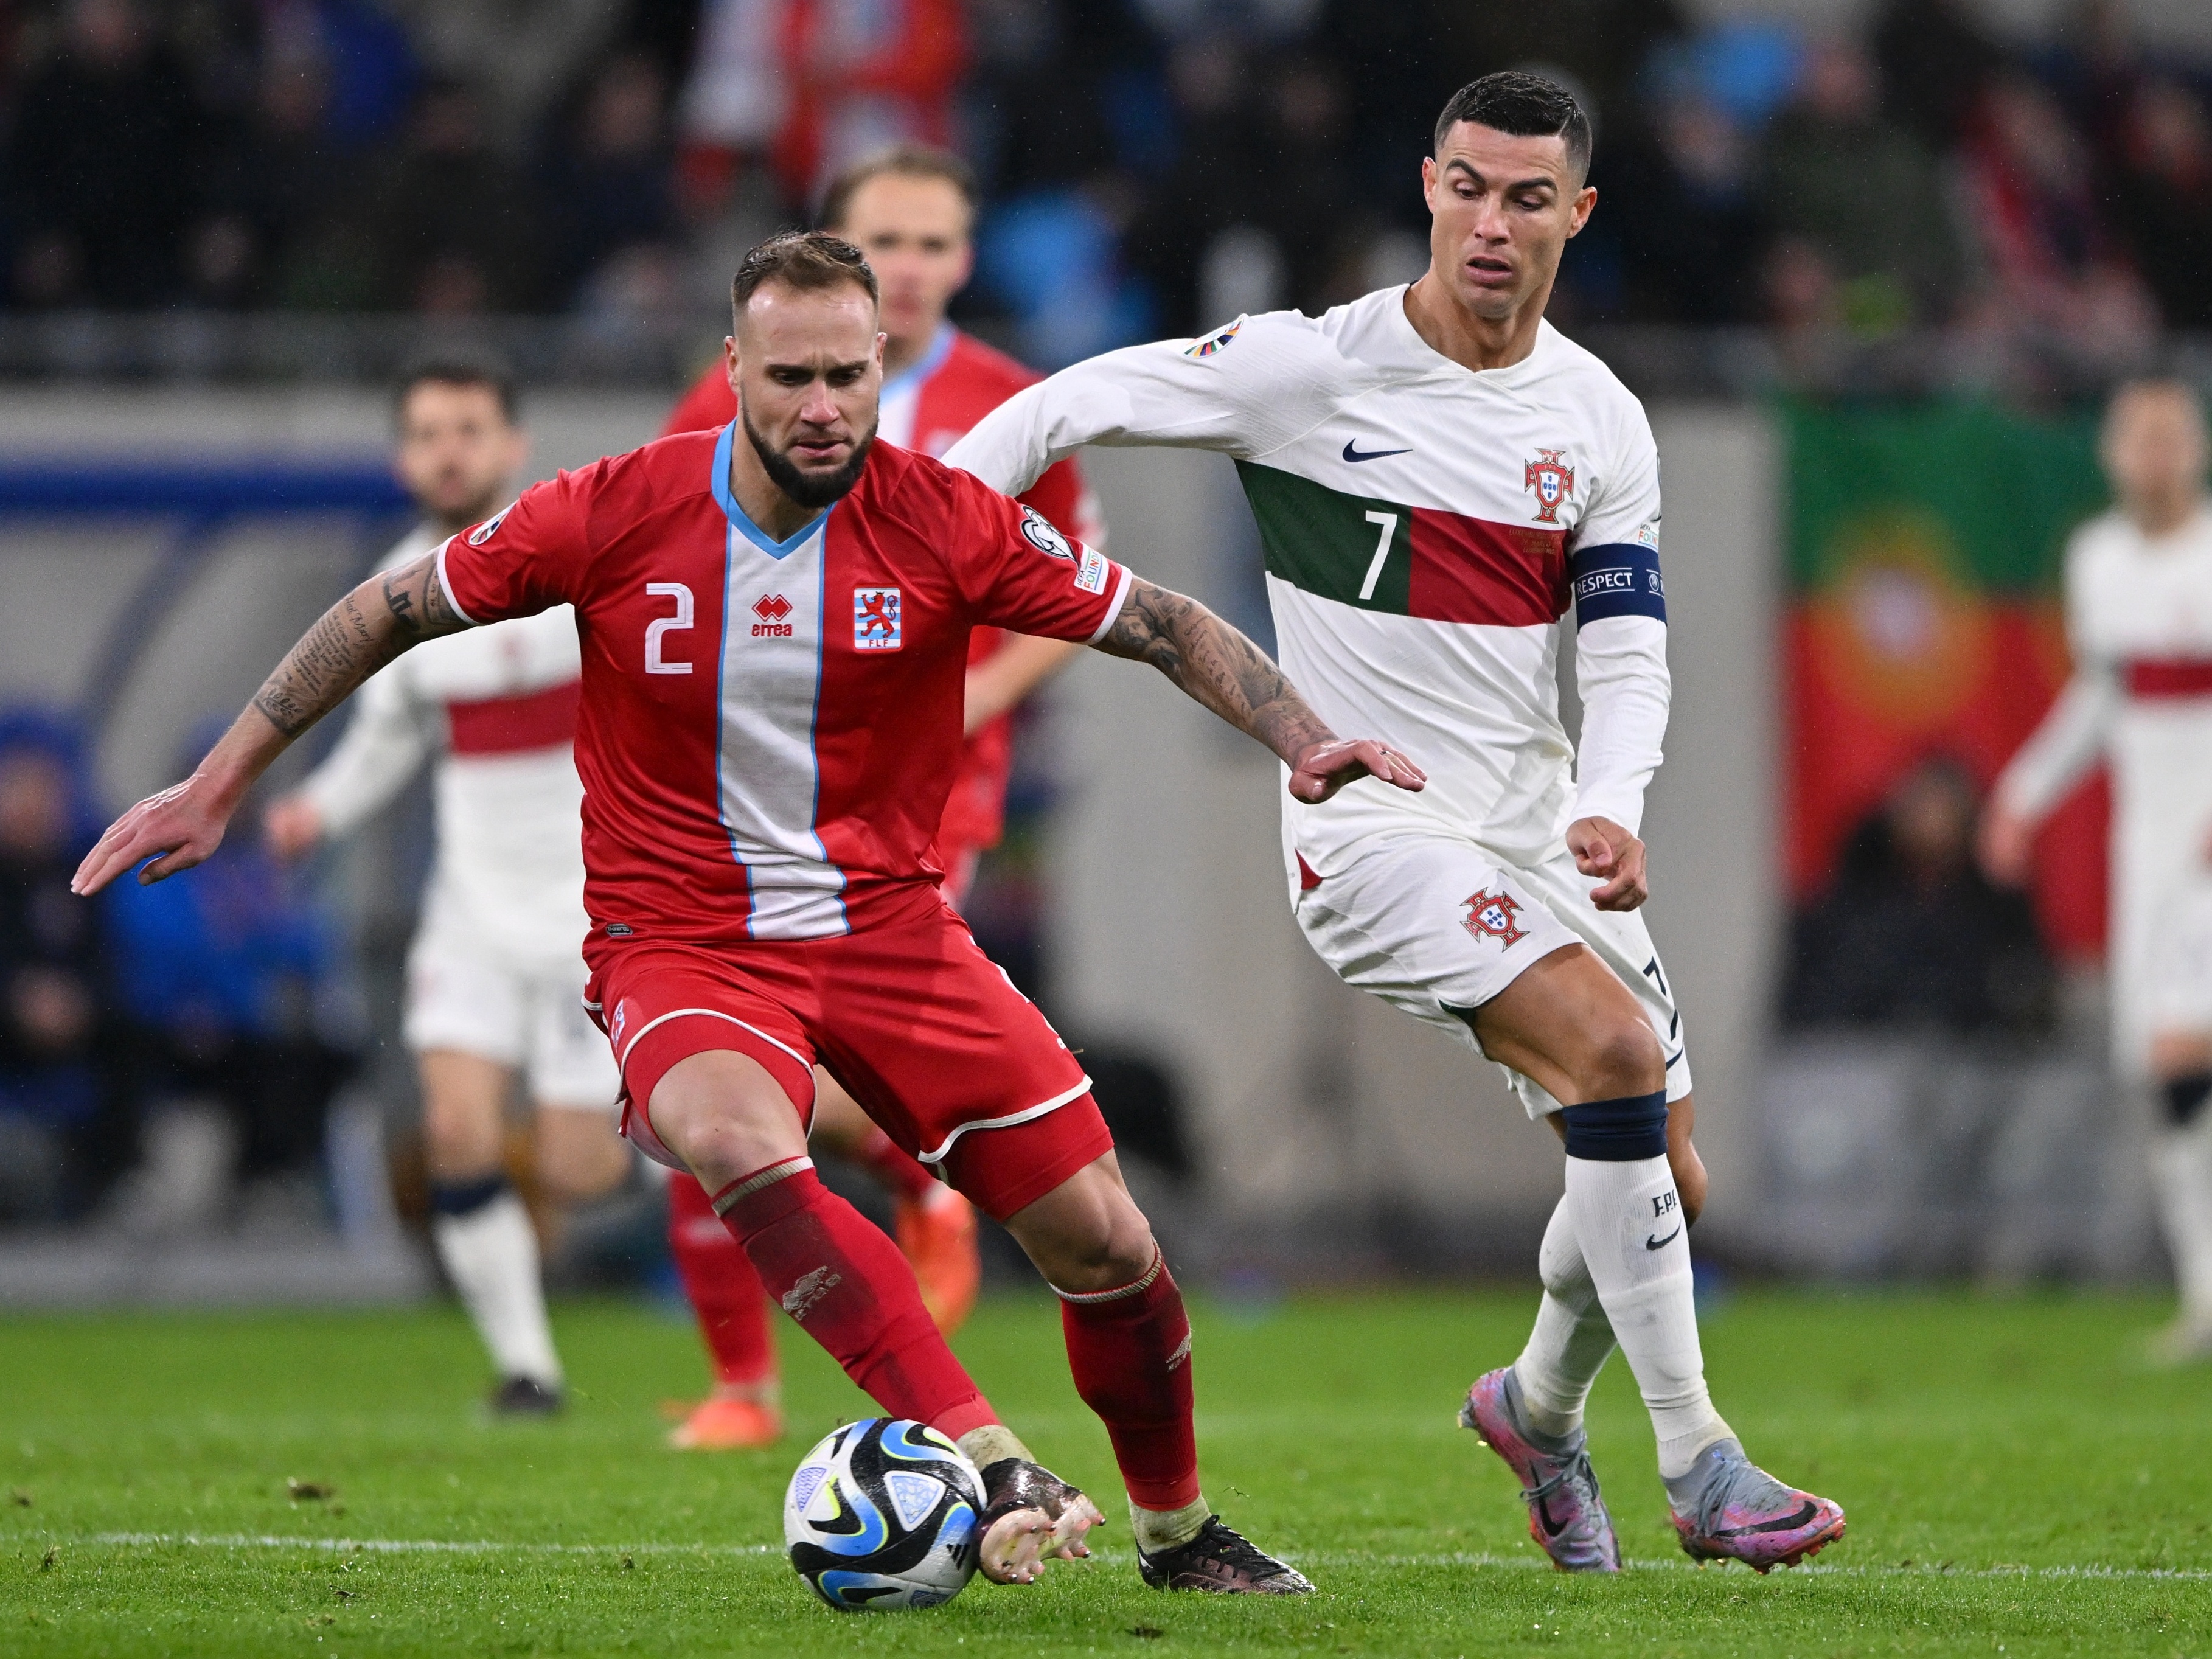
[{"left": 947, "top": 73, "right": 1845, "bottom": 1573}]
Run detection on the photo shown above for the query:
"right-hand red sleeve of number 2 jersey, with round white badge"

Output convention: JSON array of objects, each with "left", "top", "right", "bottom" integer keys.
[{"left": 949, "top": 471, "right": 1128, "bottom": 644}]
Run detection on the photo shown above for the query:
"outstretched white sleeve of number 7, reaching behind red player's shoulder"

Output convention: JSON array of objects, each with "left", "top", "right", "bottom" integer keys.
[{"left": 945, "top": 312, "right": 1349, "bottom": 495}]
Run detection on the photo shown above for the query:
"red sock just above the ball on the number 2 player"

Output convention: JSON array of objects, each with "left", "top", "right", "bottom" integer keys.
[{"left": 714, "top": 1157, "right": 995, "bottom": 1440}]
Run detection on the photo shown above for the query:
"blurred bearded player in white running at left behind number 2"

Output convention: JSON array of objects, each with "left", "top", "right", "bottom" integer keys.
[{"left": 268, "top": 361, "right": 630, "bottom": 1413}]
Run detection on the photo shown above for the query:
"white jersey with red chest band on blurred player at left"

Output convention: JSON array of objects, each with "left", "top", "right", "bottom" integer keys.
[{"left": 301, "top": 531, "right": 588, "bottom": 971}]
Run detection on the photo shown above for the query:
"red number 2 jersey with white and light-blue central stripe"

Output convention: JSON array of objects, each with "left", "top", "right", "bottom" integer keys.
[{"left": 438, "top": 422, "right": 1128, "bottom": 953}]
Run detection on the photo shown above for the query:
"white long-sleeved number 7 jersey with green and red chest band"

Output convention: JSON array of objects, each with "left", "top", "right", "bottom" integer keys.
[{"left": 947, "top": 288, "right": 1668, "bottom": 876}]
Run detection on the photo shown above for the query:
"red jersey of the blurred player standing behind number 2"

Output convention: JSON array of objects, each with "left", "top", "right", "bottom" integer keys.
[{"left": 664, "top": 323, "right": 1106, "bottom": 849}]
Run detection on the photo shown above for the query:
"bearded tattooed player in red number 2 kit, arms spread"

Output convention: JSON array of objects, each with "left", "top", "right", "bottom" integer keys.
[{"left": 75, "top": 232, "right": 1425, "bottom": 1595}]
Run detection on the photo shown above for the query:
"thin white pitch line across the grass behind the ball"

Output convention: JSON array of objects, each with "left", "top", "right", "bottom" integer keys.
[{"left": 44, "top": 1533, "right": 2212, "bottom": 1584}]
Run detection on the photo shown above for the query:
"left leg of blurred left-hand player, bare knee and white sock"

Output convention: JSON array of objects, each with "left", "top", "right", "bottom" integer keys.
[{"left": 420, "top": 1048, "right": 562, "bottom": 1396}]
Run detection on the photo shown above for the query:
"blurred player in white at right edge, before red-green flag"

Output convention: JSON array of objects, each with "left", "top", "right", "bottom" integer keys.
[{"left": 1982, "top": 380, "right": 2212, "bottom": 1360}]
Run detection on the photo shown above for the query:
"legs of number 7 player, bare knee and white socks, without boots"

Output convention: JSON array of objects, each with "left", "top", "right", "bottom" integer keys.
[{"left": 1473, "top": 945, "right": 1730, "bottom": 1478}]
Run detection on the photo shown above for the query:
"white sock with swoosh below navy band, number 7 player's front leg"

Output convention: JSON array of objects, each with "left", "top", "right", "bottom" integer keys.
[{"left": 1564, "top": 1157, "right": 1732, "bottom": 1480}]
